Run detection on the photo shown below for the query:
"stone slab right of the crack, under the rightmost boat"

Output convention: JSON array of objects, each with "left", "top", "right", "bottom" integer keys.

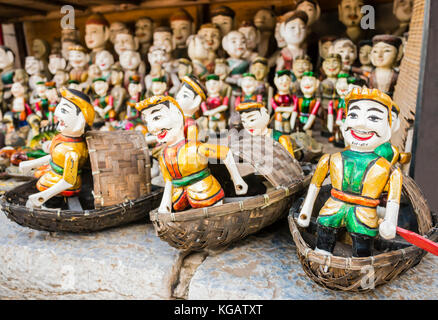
[{"left": 188, "top": 220, "right": 438, "bottom": 300}]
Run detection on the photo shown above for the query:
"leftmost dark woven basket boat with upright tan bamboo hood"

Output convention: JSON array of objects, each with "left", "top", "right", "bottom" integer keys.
[{"left": 0, "top": 131, "right": 163, "bottom": 233}]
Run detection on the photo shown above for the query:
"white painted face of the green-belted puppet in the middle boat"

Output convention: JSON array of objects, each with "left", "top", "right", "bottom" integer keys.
[{"left": 142, "top": 103, "right": 184, "bottom": 145}]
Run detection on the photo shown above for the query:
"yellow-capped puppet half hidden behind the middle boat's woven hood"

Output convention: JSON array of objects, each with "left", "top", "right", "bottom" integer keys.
[{"left": 236, "top": 102, "right": 295, "bottom": 158}]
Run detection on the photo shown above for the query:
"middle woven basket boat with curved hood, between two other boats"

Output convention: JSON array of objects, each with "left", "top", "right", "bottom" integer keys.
[{"left": 150, "top": 136, "right": 311, "bottom": 251}]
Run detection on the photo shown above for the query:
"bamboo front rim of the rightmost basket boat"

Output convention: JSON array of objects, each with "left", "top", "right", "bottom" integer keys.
[{"left": 288, "top": 213, "right": 438, "bottom": 270}]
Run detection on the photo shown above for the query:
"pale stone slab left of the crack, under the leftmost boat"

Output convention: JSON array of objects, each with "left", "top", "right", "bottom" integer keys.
[{"left": 0, "top": 212, "right": 181, "bottom": 299}]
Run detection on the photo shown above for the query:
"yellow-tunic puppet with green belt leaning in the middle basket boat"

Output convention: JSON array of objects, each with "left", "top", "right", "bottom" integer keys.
[{"left": 136, "top": 96, "right": 248, "bottom": 213}]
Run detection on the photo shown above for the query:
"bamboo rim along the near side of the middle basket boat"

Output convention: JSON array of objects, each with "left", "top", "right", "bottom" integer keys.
[{"left": 150, "top": 175, "right": 312, "bottom": 222}]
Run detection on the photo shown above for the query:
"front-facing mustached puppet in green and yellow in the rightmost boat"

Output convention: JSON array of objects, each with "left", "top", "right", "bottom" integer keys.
[{"left": 298, "top": 88, "right": 402, "bottom": 257}]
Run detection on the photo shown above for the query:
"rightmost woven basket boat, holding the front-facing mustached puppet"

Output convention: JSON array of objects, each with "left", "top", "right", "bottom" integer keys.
[{"left": 288, "top": 176, "right": 438, "bottom": 292}]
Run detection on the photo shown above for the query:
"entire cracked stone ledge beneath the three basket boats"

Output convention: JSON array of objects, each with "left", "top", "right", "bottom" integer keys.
[{"left": 0, "top": 208, "right": 438, "bottom": 300}]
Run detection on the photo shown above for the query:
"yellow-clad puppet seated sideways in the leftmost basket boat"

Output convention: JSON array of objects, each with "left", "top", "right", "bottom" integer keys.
[{"left": 20, "top": 89, "right": 94, "bottom": 207}]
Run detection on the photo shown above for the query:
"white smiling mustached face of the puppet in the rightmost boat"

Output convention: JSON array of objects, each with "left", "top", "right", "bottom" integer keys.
[{"left": 341, "top": 100, "right": 391, "bottom": 152}]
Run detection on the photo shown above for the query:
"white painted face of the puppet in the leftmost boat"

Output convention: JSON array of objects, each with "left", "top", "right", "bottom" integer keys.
[{"left": 55, "top": 98, "right": 85, "bottom": 137}]
